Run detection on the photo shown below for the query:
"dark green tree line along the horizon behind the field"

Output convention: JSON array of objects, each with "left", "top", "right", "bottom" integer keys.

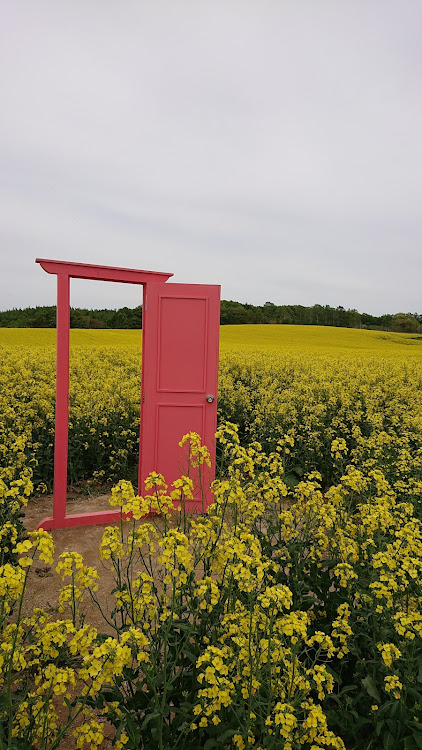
[{"left": 0, "top": 300, "right": 422, "bottom": 333}]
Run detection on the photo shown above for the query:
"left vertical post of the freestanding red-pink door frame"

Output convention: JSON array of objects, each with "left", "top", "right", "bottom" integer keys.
[{"left": 53, "top": 273, "right": 70, "bottom": 528}]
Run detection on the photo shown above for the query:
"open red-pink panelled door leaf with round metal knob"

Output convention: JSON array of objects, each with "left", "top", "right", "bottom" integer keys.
[{"left": 139, "top": 283, "right": 220, "bottom": 511}]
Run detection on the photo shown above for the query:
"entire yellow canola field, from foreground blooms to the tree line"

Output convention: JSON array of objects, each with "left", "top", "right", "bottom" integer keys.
[{"left": 0, "top": 326, "right": 422, "bottom": 750}]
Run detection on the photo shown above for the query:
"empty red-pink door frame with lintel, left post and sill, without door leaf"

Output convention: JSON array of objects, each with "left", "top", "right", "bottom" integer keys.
[{"left": 35, "top": 258, "right": 178, "bottom": 529}]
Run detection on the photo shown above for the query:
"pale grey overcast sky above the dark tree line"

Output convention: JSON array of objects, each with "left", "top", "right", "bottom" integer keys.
[{"left": 0, "top": 0, "right": 422, "bottom": 314}]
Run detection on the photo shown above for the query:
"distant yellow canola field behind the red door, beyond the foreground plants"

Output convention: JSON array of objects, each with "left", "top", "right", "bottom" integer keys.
[{"left": 0, "top": 326, "right": 422, "bottom": 503}]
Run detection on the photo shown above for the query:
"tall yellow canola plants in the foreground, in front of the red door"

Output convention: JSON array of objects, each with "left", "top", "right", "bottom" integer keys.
[{"left": 0, "top": 423, "right": 422, "bottom": 750}]
